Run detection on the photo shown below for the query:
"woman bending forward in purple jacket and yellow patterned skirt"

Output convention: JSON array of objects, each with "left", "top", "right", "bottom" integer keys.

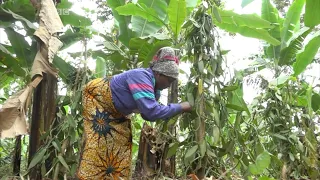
[{"left": 77, "top": 47, "right": 192, "bottom": 179}]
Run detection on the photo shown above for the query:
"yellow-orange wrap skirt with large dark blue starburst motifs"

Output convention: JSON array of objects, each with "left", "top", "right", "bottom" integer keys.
[{"left": 77, "top": 78, "right": 132, "bottom": 180}]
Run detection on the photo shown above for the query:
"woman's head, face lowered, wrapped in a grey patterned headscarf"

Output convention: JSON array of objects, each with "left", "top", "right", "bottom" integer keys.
[{"left": 150, "top": 47, "right": 179, "bottom": 90}]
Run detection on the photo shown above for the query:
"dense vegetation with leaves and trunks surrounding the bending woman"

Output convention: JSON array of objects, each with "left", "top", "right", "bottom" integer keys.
[{"left": 0, "top": 0, "right": 320, "bottom": 180}]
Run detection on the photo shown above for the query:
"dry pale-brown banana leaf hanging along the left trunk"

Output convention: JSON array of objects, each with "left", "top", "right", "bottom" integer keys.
[{"left": 0, "top": 0, "right": 63, "bottom": 138}]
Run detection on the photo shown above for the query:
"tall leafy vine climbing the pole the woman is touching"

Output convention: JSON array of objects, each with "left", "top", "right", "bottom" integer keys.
[{"left": 182, "top": 1, "right": 227, "bottom": 179}]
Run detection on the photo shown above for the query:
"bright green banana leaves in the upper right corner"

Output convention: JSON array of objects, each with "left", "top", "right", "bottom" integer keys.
[{"left": 213, "top": 0, "right": 320, "bottom": 76}]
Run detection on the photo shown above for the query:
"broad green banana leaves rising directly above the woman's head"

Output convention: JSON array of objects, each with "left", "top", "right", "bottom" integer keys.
[{"left": 76, "top": 0, "right": 197, "bottom": 73}]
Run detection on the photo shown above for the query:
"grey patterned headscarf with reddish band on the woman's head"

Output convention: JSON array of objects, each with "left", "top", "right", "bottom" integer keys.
[{"left": 150, "top": 47, "right": 179, "bottom": 79}]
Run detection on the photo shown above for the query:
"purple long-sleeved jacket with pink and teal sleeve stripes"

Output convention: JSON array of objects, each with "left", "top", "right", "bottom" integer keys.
[{"left": 110, "top": 68, "right": 182, "bottom": 121}]
